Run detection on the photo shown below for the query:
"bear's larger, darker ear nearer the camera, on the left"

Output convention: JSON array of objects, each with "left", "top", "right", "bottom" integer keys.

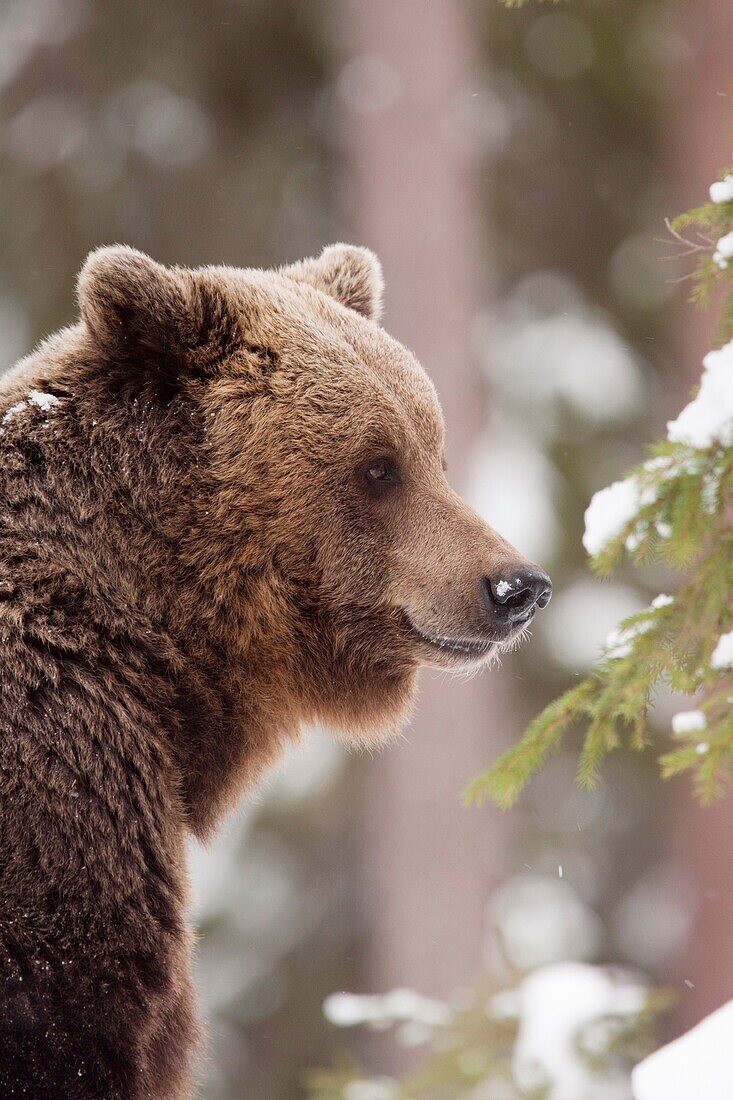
[{"left": 78, "top": 244, "right": 227, "bottom": 362}]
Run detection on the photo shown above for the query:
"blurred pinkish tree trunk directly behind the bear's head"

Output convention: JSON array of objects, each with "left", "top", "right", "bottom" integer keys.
[{"left": 337, "top": 0, "right": 504, "bottom": 993}]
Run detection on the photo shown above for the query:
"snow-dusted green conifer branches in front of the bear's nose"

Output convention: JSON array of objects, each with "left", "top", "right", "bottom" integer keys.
[{"left": 466, "top": 172, "right": 733, "bottom": 809}]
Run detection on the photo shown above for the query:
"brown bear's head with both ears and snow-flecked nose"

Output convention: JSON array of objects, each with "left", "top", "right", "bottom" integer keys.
[{"left": 79, "top": 244, "right": 550, "bottom": 740}]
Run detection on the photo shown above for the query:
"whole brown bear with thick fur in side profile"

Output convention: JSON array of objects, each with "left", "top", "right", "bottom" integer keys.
[{"left": 0, "top": 245, "right": 550, "bottom": 1100}]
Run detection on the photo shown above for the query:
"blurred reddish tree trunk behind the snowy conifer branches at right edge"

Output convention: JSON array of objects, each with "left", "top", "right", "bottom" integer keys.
[{"left": 669, "top": 0, "right": 733, "bottom": 1030}]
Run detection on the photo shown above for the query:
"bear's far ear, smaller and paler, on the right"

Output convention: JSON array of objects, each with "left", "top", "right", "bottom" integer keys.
[{"left": 280, "top": 244, "right": 384, "bottom": 321}]
